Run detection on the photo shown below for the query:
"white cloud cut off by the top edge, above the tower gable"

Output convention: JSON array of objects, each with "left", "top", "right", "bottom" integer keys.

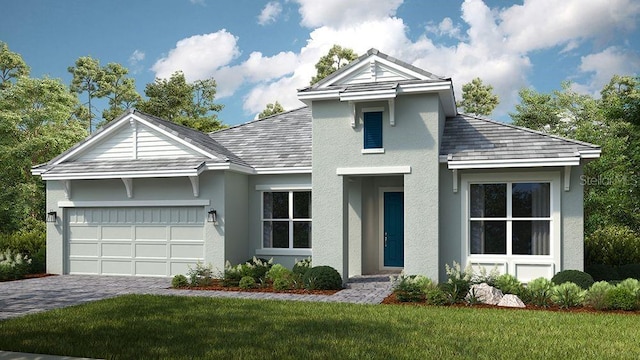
[{"left": 296, "top": 0, "right": 402, "bottom": 28}]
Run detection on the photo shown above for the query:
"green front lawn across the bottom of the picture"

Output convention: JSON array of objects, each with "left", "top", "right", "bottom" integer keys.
[{"left": 0, "top": 295, "right": 640, "bottom": 359}]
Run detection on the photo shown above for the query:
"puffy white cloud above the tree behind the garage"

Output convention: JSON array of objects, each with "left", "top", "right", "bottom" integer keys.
[{"left": 151, "top": 29, "right": 240, "bottom": 81}]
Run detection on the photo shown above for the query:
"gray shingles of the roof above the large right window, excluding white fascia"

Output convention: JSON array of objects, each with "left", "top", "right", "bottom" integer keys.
[{"left": 440, "top": 115, "right": 599, "bottom": 160}]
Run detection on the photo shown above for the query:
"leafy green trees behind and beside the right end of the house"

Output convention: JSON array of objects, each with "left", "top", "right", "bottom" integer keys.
[{"left": 510, "top": 77, "right": 640, "bottom": 235}]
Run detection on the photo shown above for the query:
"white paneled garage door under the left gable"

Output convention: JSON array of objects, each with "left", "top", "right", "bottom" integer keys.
[{"left": 66, "top": 207, "right": 205, "bottom": 276}]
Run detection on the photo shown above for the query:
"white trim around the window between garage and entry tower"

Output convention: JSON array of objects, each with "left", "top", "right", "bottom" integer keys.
[{"left": 256, "top": 190, "right": 313, "bottom": 252}]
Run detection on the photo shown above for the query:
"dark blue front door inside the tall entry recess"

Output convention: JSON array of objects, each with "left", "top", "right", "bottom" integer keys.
[{"left": 384, "top": 192, "right": 404, "bottom": 267}]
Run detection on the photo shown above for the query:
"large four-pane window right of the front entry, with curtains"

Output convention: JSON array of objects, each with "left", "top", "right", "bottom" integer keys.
[{"left": 469, "top": 182, "right": 551, "bottom": 255}]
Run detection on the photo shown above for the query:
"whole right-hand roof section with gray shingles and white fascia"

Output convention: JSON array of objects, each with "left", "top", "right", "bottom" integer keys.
[{"left": 440, "top": 115, "right": 600, "bottom": 169}]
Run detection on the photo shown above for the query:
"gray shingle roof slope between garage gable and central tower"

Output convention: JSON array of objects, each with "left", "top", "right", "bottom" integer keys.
[{"left": 209, "top": 107, "right": 311, "bottom": 169}]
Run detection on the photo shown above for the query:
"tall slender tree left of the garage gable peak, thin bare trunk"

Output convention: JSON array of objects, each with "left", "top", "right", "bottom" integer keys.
[{"left": 67, "top": 56, "right": 103, "bottom": 132}]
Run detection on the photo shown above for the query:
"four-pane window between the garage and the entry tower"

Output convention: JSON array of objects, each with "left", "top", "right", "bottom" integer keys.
[{"left": 262, "top": 191, "right": 311, "bottom": 249}]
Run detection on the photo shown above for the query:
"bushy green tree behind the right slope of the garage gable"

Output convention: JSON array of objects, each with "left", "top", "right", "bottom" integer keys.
[{"left": 138, "top": 71, "right": 224, "bottom": 132}]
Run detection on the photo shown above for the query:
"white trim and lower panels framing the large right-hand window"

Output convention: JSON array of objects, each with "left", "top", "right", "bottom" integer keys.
[{"left": 461, "top": 171, "right": 562, "bottom": 281}]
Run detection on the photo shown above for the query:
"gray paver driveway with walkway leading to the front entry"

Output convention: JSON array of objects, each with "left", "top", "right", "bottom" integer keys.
[{"left": 0, "top": 275, "right": 391, "bottom": 320}]
